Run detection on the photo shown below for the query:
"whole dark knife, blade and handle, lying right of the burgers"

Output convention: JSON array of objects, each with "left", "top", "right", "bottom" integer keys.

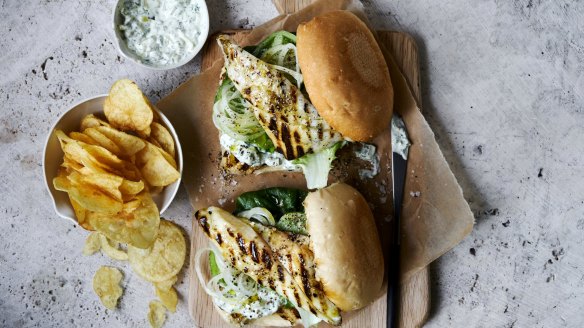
[{"left": 385, "top": 147, "right": 407, "bottom": 328}]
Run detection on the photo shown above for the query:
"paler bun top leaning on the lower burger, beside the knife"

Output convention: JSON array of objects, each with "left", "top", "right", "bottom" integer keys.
[{"left": 304, "top": 183, "right": 384, "bottom": 311}]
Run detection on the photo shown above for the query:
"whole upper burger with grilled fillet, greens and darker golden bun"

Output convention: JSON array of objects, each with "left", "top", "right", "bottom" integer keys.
[{"left": 213, "top": 11, "right": 393, "bottom": 189}]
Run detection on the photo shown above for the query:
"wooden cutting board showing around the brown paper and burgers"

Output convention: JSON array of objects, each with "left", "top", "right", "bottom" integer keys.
[{"left": 189, "top": 27, "right": 430, "bottom": 328}]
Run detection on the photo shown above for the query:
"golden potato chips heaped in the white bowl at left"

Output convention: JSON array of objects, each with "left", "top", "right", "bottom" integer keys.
[{"left": 53, "top": 80, "right": 180, "bottom": 249}]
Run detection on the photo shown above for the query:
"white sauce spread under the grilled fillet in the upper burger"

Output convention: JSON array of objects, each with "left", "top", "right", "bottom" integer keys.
[{"left": 219, "top": 133, "right": 301, "bottom": 171}]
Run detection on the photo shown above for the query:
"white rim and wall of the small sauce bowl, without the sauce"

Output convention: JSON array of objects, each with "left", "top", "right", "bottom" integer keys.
[{"left": 113, "top": 0, "right": 209, "bottom": 70}]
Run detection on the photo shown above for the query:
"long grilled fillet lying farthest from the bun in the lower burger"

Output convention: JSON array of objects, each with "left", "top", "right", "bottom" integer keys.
[{"left": 195, "top": 207, "right": 341, "bottom": 325}]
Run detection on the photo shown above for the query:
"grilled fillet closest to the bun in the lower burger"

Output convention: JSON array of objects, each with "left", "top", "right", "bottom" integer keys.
[{"left": 250, "top": 222, "right": 339, "bottom": 317}]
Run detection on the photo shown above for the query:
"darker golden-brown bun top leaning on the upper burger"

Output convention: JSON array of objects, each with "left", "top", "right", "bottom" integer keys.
[{"left": 296, "top": 10, "right": 393, "bottom": 141}]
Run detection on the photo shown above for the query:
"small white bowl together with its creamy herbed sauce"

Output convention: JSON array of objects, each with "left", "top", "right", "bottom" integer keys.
[{"left": 114, "top": 0, "right": 209, "bottom": 70}]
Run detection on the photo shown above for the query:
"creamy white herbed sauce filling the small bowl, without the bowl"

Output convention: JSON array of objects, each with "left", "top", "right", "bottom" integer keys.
[{"left": 119, "top": 0, "right": 202, "bottom": 66}]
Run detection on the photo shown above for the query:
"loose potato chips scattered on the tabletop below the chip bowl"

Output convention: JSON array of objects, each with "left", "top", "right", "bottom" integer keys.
[{"left": 83, "top": 219, "right": 187, "bottom": 327}]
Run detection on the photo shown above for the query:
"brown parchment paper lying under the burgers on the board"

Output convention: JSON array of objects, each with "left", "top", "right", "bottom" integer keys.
[{"left": 157, "top": 0, "right": 474, "bottom": 281}]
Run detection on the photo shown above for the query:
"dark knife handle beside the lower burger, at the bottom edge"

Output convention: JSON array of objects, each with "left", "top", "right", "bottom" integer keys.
[{"left": 386, "top": 243, "right": 400, "bottom": 328}]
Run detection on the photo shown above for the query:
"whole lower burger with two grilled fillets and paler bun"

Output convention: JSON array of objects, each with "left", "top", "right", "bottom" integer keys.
[{"left": 195, "top": 183, "right": 383, "bottom": 327}]
